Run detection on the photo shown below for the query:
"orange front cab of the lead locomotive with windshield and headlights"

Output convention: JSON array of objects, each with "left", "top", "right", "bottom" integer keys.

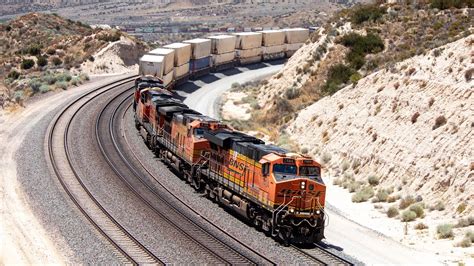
[{"left": 260, "top": 153, "right": 326, "bottom": 243}]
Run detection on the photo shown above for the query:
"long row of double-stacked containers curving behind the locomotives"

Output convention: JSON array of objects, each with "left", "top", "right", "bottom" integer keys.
[{"left": 139, "top": 28, "right": 309, "bottom": 89}]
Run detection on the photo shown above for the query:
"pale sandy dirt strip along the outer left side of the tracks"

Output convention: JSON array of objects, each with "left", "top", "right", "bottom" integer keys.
[{"left": 0, "top": 77, "right": 130, "bottom": 265}]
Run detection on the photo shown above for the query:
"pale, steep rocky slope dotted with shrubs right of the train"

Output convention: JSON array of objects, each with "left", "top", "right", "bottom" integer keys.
[{"left": 288, "top": 35, "right": 474, "bottom": 213}]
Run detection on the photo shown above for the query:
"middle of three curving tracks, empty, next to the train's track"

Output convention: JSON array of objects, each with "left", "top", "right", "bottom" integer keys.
[{"left": 96, "top": 87, "right": 274, "bottom": 264}]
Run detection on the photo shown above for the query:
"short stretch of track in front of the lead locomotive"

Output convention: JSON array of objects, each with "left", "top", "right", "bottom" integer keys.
[{"left": 291, "top": 245, "right": 354, "bottom": 265}]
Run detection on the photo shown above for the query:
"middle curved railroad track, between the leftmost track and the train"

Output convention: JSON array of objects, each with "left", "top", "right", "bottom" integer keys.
[{"left": 96, "top": 87, "right": 275, "bottom": 264}]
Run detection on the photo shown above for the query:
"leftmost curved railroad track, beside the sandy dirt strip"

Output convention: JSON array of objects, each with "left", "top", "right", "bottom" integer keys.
[{"left": 47, "top": 77, "right": 164, "bottom": 265}]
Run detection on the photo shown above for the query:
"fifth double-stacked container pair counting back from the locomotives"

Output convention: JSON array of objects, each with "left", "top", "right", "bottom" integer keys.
[{"left": 234, "top": 32, "right": 262, "bottom": 65}]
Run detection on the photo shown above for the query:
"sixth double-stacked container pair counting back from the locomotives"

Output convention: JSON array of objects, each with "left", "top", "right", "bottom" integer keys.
[{"left": 260, "top": 30, "right": 286, "bottom": 60}]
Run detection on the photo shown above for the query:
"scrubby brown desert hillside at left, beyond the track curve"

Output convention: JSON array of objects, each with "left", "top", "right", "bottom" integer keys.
[{"left": 0, "top": 13, "right": 147, "bottom": 108}]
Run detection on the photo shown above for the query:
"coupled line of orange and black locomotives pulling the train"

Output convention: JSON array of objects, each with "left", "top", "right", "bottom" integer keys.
[{"left": 134, "top": 78, "right": 326, "bottom": 244}]
